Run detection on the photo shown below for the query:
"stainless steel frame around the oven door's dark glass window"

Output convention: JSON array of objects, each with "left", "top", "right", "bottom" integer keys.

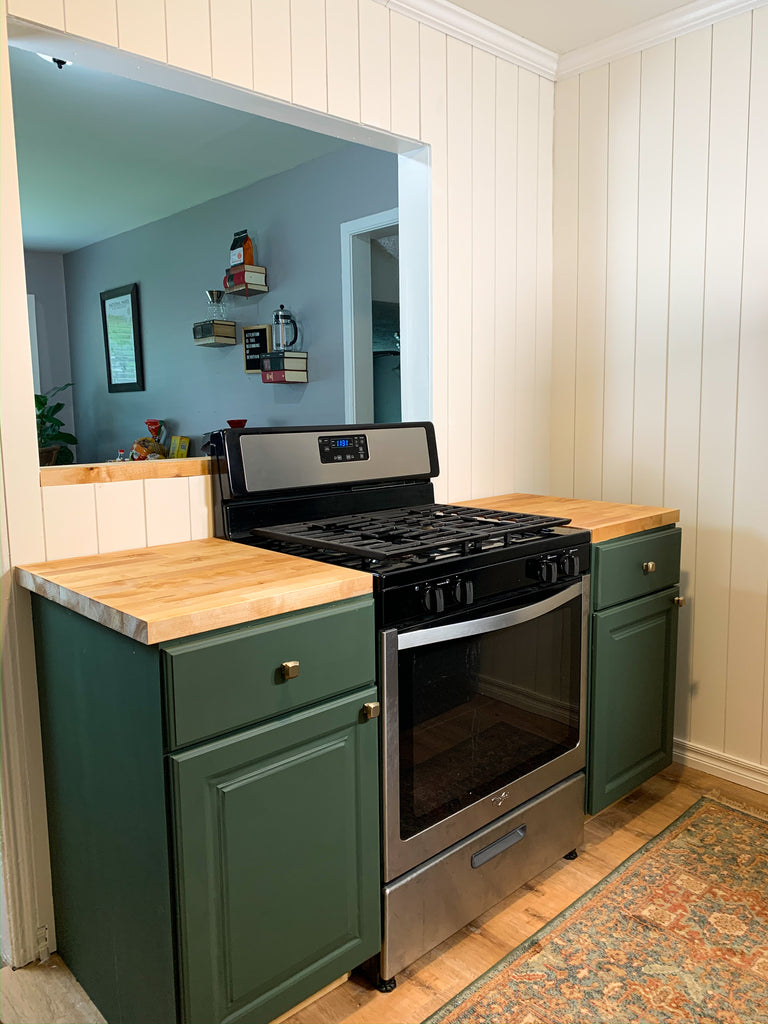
[{"left": 379, "top": 575, "right": 590, "bottom": 882}]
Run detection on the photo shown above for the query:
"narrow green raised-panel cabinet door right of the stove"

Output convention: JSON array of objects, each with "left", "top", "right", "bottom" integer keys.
[{"left": 587, "top": 587, "right": 679, "bottom": 814}]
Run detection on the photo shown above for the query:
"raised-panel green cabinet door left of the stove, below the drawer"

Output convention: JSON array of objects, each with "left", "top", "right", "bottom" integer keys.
[{"left": 170, "top": 687, "right": 380, "bottom": 1024}]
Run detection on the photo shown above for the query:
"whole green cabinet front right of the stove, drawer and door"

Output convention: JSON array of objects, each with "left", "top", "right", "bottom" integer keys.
[{"left": 587, "top": 526, "right": 681, "bottom": 814}]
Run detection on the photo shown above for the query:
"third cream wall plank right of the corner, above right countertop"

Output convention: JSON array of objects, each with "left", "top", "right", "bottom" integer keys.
[{"left": 602, "top": 53, "right": 640, "bottom": 502}]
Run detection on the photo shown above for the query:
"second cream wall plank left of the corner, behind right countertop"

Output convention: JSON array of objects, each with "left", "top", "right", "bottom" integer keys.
[{"left": 513, "top": 69, "right": 539, "bottom": 492}]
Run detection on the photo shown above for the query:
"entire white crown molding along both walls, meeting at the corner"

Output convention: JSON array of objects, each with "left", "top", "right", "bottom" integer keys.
[{"left": 375, "top": 0, "right": 768, "bottom": 81}]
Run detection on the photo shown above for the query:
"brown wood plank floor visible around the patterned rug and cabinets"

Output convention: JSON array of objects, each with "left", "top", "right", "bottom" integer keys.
[{"left": 0, "top": 765, "right": 768, "bottom": 1024}]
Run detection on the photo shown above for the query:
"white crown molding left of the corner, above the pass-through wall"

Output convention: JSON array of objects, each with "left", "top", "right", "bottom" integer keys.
[{"left": 376, "top": 0, "right": 557, "bottom": 82}]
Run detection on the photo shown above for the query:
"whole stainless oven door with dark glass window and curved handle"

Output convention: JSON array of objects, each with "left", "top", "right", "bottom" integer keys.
[{"left": 380, "top": 575, "right": 589, "bottom": 882}]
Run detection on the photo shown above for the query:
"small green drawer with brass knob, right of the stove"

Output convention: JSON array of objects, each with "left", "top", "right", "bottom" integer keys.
[{"left": 592, "top": 526, "right": 681, "bottom": 609}]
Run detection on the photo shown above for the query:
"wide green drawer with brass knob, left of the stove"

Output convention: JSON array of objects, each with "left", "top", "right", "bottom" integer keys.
[{"left": 161, "top": 597, "right": 375, "bottom": 750}]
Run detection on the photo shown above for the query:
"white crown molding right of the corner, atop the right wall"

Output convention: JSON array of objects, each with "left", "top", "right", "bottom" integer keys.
[{"left": 556, "top": 0, "right": 768, "bottom": 81}]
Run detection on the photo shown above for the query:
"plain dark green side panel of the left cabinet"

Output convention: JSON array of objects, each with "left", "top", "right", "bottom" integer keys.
[{"left": 33, "top": 596, "right": 177, "bottom": 1024}]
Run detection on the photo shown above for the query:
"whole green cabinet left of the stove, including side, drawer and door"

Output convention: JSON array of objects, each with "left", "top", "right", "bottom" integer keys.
[{"left": 33, "top": 596, "right": 380, "bottom": 1024}]
